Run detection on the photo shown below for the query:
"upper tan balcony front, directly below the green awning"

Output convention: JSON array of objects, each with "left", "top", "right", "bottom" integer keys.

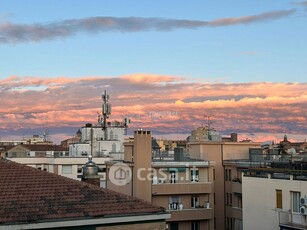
[{"left": 152, "top": 182, "right": 213, "bottom": 195}]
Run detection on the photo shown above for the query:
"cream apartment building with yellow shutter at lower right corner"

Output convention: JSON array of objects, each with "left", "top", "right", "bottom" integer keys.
[{"left": 242, "top": 160, "right": 307, "bottom": 230}]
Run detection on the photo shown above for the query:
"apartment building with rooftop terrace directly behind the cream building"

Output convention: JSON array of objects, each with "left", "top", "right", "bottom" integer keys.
[{"left": 223, "top": 135, "right": 306, "bottom": 230}]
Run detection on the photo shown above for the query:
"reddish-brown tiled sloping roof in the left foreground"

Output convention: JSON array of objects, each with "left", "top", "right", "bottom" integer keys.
[{"left": 0, "top": 158, "right": 165, "bottom": 225}]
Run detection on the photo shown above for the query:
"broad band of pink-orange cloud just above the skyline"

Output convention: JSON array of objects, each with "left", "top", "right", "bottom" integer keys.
[{"left": 0, "top": 74, "right": 307, "bottom": 142}]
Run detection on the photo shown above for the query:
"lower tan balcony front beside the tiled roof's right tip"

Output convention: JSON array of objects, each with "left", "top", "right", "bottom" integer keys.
[{"left": 167, "top": 208, "right": 214, "bottom": 221}]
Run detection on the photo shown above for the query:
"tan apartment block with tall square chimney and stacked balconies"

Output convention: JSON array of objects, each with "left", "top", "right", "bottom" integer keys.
[{"left": 106, "top": 130, "right": 214, "bottom": 230}]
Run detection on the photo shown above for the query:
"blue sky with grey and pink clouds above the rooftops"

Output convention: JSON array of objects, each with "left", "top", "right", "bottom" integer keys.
[{"left": 0, "top": 0, "right": 307, "bottom": 142}]
